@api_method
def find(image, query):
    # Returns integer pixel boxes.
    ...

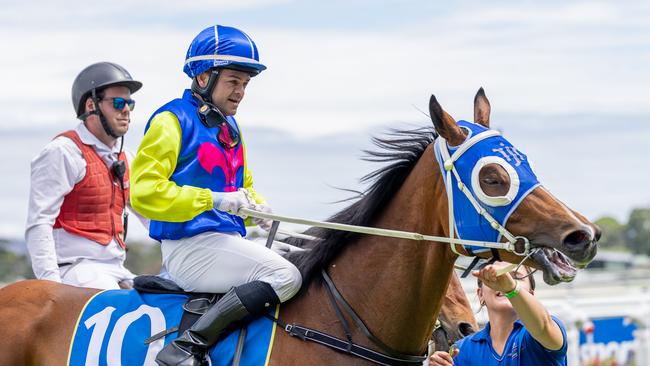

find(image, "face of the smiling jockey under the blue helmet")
[212,69,251,116]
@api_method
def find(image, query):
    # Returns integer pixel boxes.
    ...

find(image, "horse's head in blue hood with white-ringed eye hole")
[429,88,600,285]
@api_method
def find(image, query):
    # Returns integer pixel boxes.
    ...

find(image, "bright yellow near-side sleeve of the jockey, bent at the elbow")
[131,112,213,222]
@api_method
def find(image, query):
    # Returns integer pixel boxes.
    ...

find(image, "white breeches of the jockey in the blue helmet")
[161,232,302,302]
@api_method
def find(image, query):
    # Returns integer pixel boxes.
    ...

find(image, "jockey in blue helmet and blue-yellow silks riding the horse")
[131,25,302,365]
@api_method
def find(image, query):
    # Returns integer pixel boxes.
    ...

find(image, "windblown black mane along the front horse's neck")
[286,126,437,288]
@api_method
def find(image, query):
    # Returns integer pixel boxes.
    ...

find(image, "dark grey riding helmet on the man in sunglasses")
[72,62,142,117]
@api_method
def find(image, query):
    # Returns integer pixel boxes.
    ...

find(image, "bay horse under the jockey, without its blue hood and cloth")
[0,89,600,366]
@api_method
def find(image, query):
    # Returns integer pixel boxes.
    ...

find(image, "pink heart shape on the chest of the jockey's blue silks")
[197,142,244,192]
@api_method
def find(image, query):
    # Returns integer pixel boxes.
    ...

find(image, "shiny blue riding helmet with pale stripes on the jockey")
[183,25,266,78]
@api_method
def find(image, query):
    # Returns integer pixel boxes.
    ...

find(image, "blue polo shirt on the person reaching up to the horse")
[454,316,567,366]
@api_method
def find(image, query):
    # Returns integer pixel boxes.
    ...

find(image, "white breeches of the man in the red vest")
[60,258,135,290]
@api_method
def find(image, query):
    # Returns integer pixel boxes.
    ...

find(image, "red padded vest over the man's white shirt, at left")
[54,131,129,248]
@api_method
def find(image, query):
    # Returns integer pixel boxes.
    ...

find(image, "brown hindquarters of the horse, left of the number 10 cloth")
[0,280,97,366]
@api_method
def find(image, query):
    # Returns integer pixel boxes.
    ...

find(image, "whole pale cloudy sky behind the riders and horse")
[0,0,650,242]
